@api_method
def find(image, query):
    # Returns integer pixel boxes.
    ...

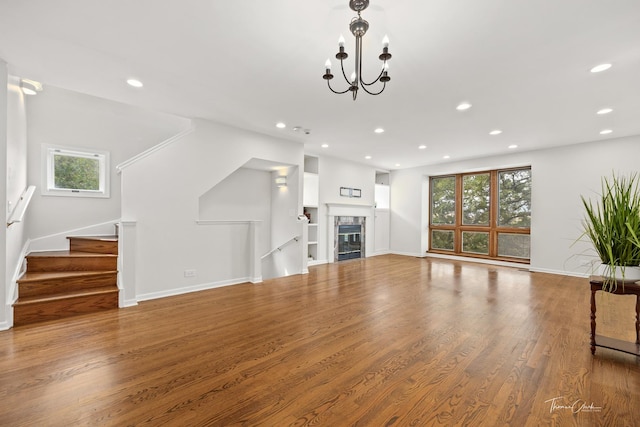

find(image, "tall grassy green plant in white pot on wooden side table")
[581,173,640,292]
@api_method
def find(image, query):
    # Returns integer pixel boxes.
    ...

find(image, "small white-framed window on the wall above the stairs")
[42,145,109,197]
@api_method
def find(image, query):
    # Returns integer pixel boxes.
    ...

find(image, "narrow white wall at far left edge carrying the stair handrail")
[0,69,27,329]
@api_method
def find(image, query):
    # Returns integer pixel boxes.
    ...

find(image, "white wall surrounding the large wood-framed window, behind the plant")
[391,136,640,275]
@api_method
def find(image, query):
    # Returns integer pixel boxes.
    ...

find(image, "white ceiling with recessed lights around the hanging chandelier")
[0,0,640,170]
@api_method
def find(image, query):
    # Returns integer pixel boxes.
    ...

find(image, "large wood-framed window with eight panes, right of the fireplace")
[429,167,531,262]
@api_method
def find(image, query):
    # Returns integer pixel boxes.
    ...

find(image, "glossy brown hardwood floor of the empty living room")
[0,255,640,426]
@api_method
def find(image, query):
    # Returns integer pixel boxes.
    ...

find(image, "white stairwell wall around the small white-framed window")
[27,85,190,239]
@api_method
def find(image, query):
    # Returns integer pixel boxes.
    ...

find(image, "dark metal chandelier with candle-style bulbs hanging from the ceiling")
[322,0,391,101]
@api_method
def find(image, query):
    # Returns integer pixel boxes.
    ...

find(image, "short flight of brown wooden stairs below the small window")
[13,236,118,326]
